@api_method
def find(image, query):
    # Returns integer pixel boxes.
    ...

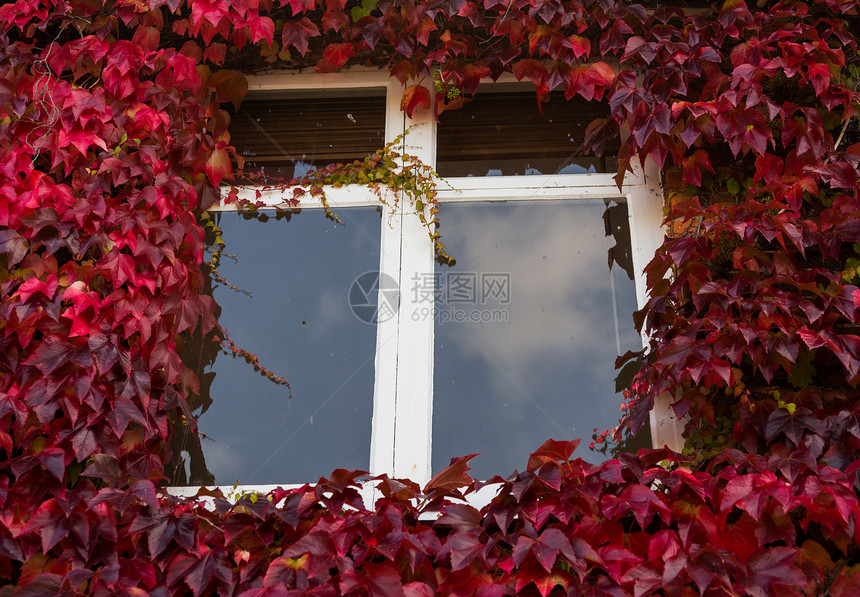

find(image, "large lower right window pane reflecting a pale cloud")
[433,200,641,478]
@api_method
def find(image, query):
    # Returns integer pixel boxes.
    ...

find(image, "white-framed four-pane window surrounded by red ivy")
[166,72,662,498]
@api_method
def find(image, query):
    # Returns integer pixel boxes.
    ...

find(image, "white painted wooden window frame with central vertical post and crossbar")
[170,69,682,498]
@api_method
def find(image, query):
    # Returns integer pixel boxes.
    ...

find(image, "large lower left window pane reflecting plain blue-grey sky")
[199,208,380,484]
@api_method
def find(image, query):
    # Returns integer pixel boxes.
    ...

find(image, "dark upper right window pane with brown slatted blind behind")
[436,92,618,176]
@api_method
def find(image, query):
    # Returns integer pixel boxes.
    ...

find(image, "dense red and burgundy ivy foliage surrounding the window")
[0,0,860,597]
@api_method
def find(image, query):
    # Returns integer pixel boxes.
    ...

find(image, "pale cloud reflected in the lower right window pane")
[444,203,632,379]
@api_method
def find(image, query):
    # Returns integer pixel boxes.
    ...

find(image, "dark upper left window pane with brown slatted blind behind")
[230,89,385,182]
